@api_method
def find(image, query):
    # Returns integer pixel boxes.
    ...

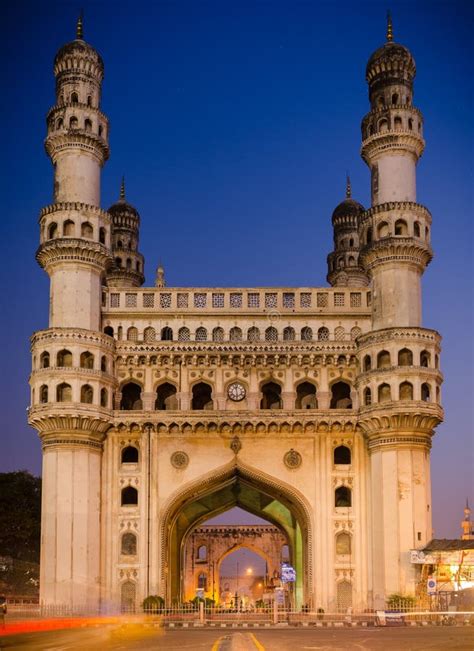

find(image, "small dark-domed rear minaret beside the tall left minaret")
[107,178,145,287]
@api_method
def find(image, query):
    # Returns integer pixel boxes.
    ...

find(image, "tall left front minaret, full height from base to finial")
[29,17,115,611]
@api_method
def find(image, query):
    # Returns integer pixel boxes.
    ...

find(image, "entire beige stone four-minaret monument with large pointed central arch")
[29,16,443,610]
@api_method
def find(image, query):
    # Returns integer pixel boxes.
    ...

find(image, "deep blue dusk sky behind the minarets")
[0,0,474,537]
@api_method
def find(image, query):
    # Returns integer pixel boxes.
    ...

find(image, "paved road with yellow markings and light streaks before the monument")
[0,626,474,651]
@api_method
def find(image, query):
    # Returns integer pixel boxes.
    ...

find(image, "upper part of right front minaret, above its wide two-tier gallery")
[359,16,432,329]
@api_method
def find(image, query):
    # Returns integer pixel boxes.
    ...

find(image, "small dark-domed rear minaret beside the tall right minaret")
[327,175,369,287]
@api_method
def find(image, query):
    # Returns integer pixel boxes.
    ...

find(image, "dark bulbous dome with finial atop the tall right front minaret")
[365,14,416,85]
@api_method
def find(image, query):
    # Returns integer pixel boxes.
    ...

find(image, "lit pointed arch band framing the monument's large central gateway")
[161,462,313,607]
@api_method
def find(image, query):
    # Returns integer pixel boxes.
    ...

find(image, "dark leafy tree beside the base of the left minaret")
[0,470,41,563]
